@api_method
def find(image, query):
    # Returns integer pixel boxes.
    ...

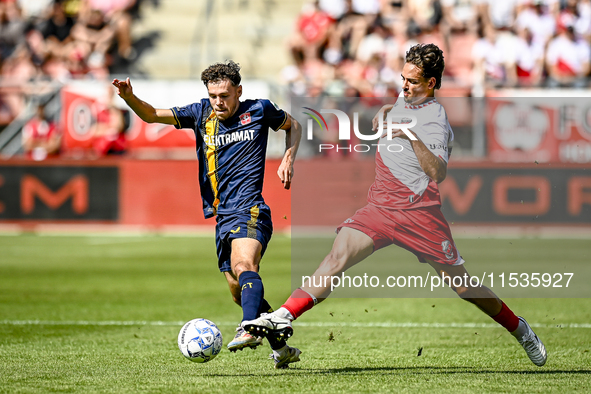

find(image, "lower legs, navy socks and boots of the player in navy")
[226,238,301,368]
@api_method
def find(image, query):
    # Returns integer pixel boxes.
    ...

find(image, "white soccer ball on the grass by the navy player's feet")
[178,319,222,363]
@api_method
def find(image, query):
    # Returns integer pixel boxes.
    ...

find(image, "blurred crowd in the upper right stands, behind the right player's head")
[282,0,591,97]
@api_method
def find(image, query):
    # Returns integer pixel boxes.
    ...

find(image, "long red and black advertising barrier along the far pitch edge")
[0,159,591,230]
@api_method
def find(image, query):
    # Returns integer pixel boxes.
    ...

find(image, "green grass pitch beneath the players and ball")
[0,235,591,393]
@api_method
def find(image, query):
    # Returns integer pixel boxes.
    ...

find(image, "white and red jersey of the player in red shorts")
[368,95,454,209]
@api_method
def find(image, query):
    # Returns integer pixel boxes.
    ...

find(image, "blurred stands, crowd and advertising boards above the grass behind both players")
[0,0,591,233]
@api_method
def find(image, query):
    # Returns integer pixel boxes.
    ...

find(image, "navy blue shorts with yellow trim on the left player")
[215,204,273,272]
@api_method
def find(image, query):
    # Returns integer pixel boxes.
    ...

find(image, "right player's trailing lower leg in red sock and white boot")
[427,260,548,367]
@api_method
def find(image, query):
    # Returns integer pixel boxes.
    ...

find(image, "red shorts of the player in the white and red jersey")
[337,204,464,265]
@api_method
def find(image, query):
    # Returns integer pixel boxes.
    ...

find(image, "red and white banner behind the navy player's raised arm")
[60,80,269,158]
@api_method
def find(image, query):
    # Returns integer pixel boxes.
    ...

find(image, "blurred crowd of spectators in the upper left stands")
[0,0,140,124]
